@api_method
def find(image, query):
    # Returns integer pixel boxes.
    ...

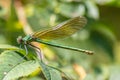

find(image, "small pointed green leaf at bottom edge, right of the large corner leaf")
[39,61,62,80]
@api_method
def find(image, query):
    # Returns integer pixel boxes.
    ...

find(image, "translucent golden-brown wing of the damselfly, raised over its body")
[32,17,87,40]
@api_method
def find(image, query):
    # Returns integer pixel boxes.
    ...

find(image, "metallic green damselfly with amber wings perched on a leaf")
[17,17,93,58]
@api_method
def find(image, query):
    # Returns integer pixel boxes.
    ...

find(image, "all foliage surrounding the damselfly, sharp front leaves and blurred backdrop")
[0,0,120,80]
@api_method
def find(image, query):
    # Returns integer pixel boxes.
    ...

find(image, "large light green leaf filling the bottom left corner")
[0,51,39,80]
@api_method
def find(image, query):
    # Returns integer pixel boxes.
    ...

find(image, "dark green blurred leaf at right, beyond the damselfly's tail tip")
[91,23,116,59]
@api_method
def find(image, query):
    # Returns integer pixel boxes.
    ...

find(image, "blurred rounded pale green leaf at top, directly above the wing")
[58,3,85,18]
